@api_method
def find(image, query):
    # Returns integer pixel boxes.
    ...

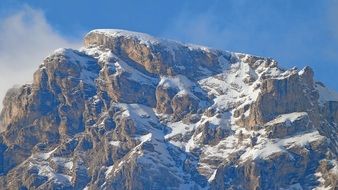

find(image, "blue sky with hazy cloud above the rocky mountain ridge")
[0,0,338,97]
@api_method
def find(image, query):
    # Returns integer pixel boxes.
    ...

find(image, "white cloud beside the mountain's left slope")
[0,6,80,109]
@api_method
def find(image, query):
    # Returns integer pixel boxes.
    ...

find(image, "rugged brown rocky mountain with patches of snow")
[0,30,338,190]
